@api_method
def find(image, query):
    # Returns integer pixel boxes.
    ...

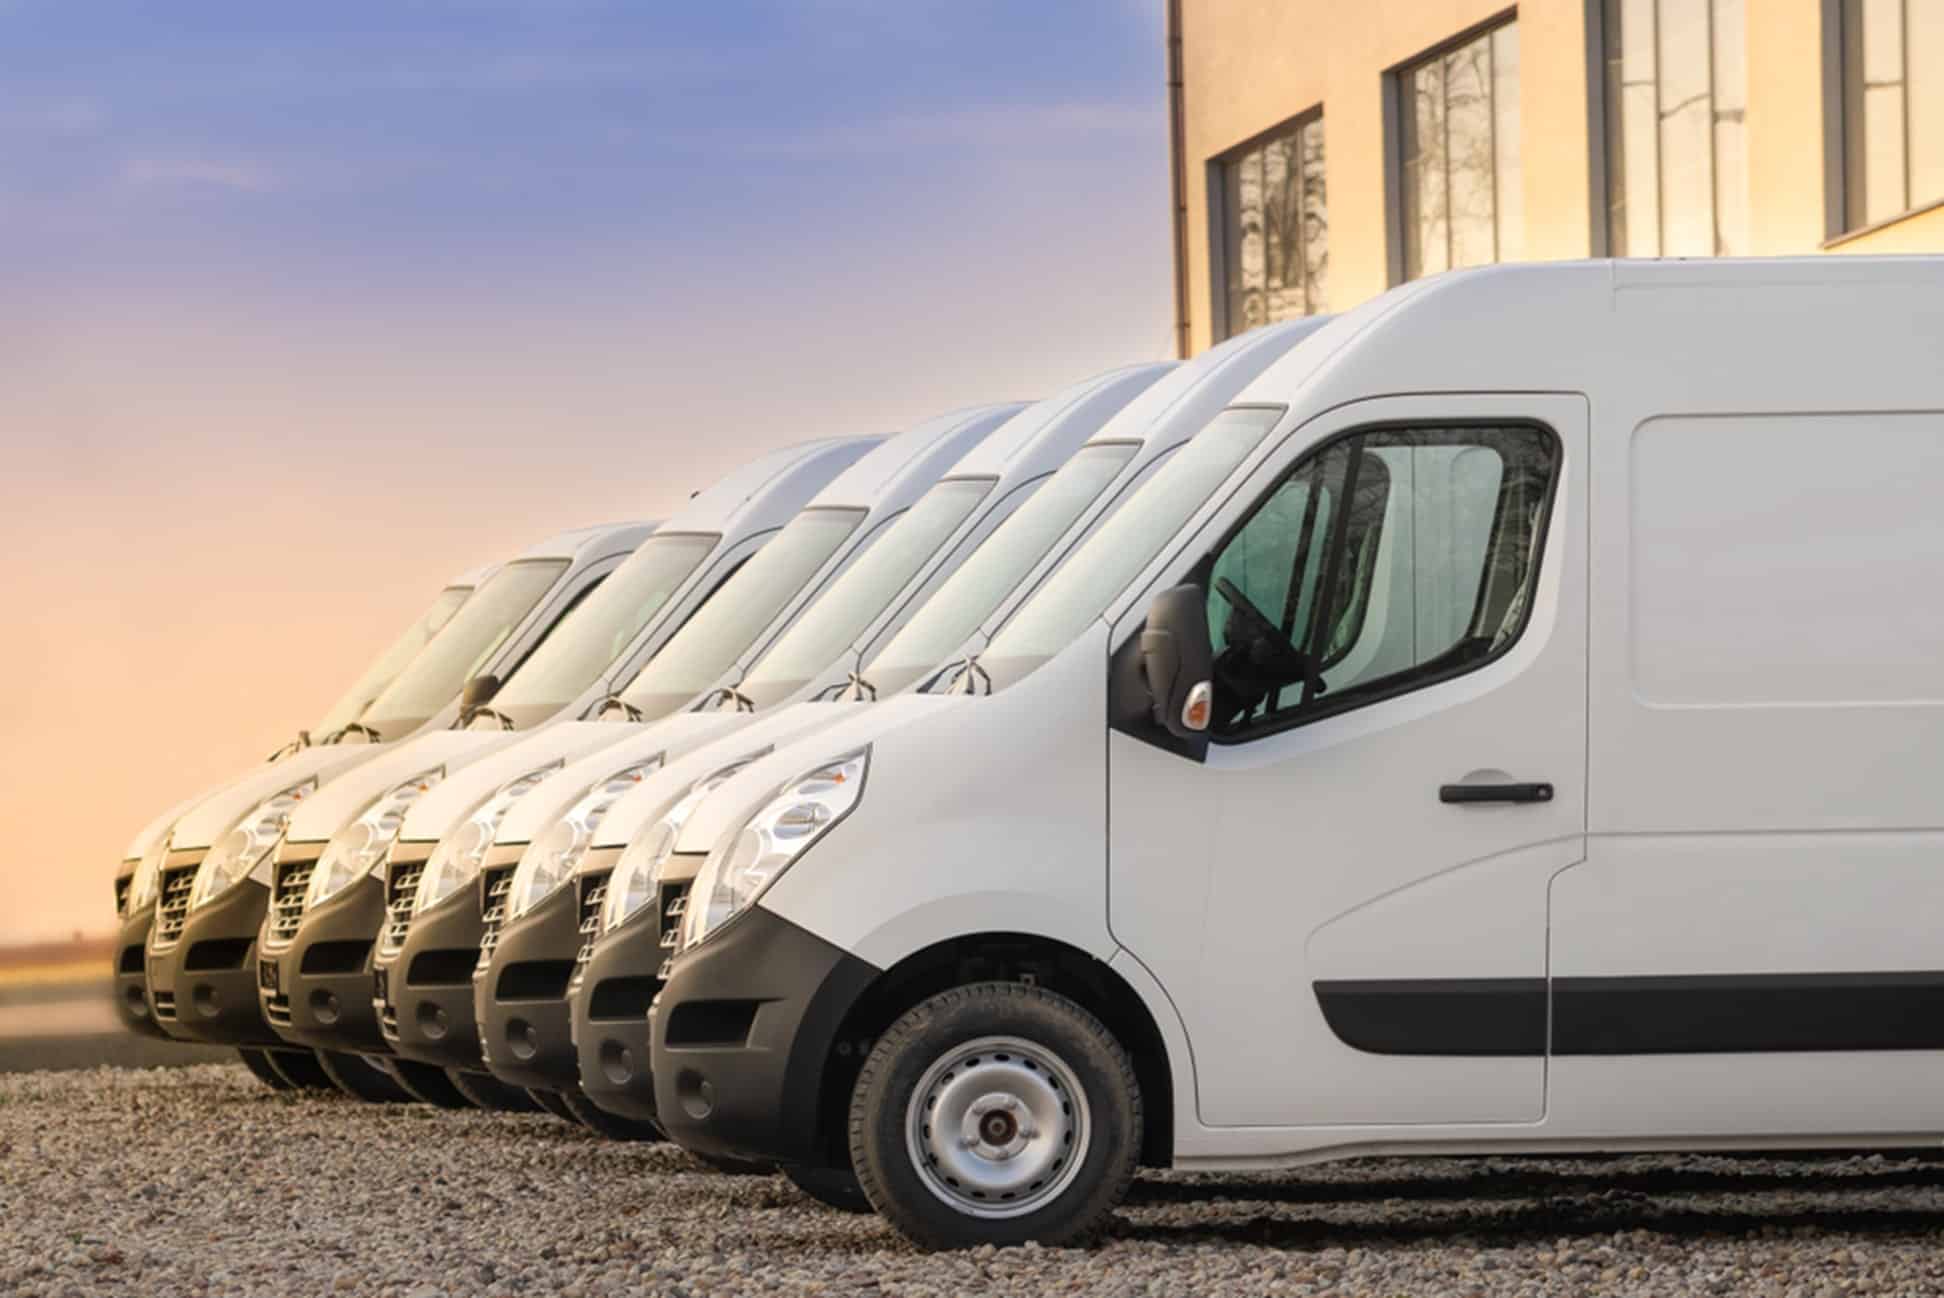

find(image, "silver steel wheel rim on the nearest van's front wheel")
[904,1036,1093,1218]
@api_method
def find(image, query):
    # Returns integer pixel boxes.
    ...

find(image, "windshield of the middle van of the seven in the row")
[622,509,865,721]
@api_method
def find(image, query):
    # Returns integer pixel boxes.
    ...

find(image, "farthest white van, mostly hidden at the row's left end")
[115,567,482,1080]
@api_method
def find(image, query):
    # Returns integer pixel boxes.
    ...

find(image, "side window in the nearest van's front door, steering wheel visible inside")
[1201,426,1559,736]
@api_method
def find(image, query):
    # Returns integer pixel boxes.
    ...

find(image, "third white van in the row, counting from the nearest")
[454,365,1172,1137]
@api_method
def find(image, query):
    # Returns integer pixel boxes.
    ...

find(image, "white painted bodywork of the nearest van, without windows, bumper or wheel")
[734,258,1944,1168]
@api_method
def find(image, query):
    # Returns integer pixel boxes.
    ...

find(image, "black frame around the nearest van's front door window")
[1186,416,1567,746]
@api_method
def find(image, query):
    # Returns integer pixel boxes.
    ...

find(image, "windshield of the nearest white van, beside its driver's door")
[972,406,1283,690]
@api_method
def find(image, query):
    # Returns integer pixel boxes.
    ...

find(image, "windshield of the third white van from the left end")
[494,534,717,713]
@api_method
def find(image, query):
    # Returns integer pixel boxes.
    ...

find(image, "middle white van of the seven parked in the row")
[365,406,1017,1113]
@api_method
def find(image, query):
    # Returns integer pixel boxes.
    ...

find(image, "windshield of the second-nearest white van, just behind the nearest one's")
[859,441,1139,694]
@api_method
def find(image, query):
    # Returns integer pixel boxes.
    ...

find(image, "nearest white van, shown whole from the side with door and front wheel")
[651,256,1944,1246]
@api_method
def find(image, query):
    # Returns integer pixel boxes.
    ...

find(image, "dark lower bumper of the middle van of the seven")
[365,888,484,1073]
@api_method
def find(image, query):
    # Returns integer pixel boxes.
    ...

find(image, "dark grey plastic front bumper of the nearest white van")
[649,905,879,1164]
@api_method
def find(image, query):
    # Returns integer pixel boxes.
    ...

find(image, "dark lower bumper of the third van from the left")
[257,876,385,1053]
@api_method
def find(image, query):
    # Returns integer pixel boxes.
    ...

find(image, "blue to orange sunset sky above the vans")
[0,0,1170,944]
